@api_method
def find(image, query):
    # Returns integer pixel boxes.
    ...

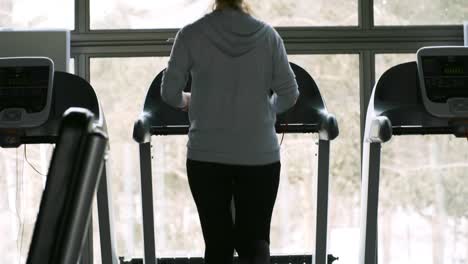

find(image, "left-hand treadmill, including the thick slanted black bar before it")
[0,57,117,264]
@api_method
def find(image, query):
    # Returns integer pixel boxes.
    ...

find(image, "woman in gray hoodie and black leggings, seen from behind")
[161,0,299,264]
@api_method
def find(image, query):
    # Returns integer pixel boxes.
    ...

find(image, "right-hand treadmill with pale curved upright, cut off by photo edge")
[359,47,468,264]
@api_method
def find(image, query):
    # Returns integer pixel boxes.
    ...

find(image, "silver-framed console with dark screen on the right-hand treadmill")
[417,47,468,118]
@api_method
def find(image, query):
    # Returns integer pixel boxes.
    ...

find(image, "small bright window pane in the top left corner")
[0,0,75,29]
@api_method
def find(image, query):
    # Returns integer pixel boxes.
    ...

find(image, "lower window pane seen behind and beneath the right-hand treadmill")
[376,54,468,264]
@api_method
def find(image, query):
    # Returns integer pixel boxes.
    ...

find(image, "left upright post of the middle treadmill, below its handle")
[140,143,156,264]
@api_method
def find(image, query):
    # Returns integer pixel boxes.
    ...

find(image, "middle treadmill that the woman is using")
[132,63,339,264]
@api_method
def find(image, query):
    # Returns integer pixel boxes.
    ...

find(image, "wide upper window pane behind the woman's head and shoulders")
[91,0,358,29]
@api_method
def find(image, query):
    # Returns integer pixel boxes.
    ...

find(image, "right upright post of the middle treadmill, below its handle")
[314,139,330,264]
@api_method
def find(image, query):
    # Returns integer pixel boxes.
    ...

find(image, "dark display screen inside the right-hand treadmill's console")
[422,56,468,103]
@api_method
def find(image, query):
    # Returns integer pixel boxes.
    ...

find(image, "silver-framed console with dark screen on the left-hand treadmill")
[0,57,54,128]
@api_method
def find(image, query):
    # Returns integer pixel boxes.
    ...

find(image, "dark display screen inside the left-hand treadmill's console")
[0,66,49,113]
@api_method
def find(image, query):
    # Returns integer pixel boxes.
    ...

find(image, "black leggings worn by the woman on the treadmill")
[187,159,281,264]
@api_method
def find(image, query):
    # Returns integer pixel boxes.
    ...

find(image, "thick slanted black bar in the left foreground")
[27,108,107,264]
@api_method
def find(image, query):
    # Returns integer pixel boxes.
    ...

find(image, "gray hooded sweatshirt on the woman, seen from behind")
[161,9,299,165]
